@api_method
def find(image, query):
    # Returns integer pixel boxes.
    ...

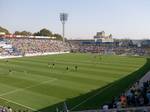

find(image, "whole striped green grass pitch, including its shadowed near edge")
[0,54,149,112]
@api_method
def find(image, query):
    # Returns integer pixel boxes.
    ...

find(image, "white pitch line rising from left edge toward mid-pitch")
[0,79,58,97]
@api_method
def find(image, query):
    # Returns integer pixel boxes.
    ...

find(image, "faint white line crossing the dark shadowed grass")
[70,84,113,110]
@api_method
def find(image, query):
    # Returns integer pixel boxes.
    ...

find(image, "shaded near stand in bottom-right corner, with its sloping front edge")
[101,72,150,112]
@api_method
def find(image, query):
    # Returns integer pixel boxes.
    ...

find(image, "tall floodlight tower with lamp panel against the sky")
[60,13,68,42]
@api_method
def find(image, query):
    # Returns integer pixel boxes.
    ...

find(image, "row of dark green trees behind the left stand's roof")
[0,26,62,40]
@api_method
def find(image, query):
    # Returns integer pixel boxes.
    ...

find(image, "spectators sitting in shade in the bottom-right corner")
[102,81,150,112]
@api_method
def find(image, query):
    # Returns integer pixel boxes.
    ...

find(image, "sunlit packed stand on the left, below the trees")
[0,38,70,55]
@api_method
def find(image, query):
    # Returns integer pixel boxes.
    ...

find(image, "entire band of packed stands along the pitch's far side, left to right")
[0,37,150,56]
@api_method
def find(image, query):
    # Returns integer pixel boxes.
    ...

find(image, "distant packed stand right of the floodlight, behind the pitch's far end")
[68,40,150,56]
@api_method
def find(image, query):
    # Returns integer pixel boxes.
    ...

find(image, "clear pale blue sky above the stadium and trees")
[0,0,150,39]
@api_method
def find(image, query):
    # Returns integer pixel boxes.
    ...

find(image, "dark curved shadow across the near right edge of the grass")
[34,59,150,112]
